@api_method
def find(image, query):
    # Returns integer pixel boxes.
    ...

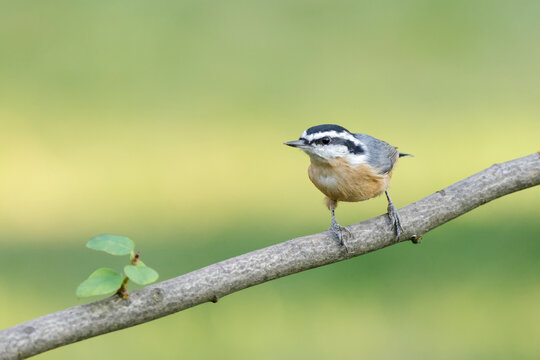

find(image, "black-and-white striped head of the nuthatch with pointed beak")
[285,124,366,164]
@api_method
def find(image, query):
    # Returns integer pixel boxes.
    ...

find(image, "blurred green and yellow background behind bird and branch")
[0,0,540,359]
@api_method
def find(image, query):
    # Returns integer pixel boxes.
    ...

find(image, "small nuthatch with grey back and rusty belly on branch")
[284,124,412,245]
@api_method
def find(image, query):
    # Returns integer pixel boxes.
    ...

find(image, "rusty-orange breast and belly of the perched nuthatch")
[308,158,392,201]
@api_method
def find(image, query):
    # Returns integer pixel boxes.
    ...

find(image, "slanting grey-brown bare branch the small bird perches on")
[0,153,540,360]
